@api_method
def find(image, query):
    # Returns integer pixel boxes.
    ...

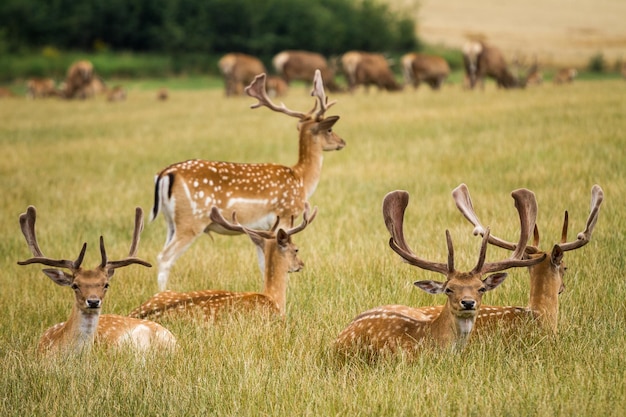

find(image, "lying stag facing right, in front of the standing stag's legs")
[129,203,317,320]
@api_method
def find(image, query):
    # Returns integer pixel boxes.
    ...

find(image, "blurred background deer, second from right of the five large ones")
[400,52,450,90]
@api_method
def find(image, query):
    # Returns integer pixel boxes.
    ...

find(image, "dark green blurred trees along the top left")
[0,0,417,57]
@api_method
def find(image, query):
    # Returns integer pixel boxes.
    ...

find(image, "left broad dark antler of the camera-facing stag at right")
[383,190,449,275]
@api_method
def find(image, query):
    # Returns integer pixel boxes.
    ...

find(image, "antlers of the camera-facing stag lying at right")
[383,191,545,275]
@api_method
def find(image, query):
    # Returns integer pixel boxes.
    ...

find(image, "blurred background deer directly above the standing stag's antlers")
[272,51,341,92]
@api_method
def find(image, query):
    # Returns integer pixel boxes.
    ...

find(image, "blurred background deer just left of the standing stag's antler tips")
[217,53,266,97]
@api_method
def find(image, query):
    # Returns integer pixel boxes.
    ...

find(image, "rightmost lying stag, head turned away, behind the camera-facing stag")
[452,184,604,333]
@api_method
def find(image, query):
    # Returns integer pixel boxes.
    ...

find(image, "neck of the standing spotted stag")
[292,128,324,198]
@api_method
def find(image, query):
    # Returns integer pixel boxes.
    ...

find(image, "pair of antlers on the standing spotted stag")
[244,70,336,121]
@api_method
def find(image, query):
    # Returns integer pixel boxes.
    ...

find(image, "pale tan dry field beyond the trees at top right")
[386,0,626,67]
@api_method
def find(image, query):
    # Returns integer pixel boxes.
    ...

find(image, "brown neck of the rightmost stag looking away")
[529,261,561,330]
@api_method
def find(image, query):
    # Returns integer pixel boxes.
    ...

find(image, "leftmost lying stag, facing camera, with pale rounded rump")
[18,206,176,353]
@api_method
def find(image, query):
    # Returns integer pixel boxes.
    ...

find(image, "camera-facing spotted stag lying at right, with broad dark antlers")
[335,191,543,354]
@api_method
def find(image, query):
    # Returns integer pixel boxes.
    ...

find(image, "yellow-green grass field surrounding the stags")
[0,80,626,417]
